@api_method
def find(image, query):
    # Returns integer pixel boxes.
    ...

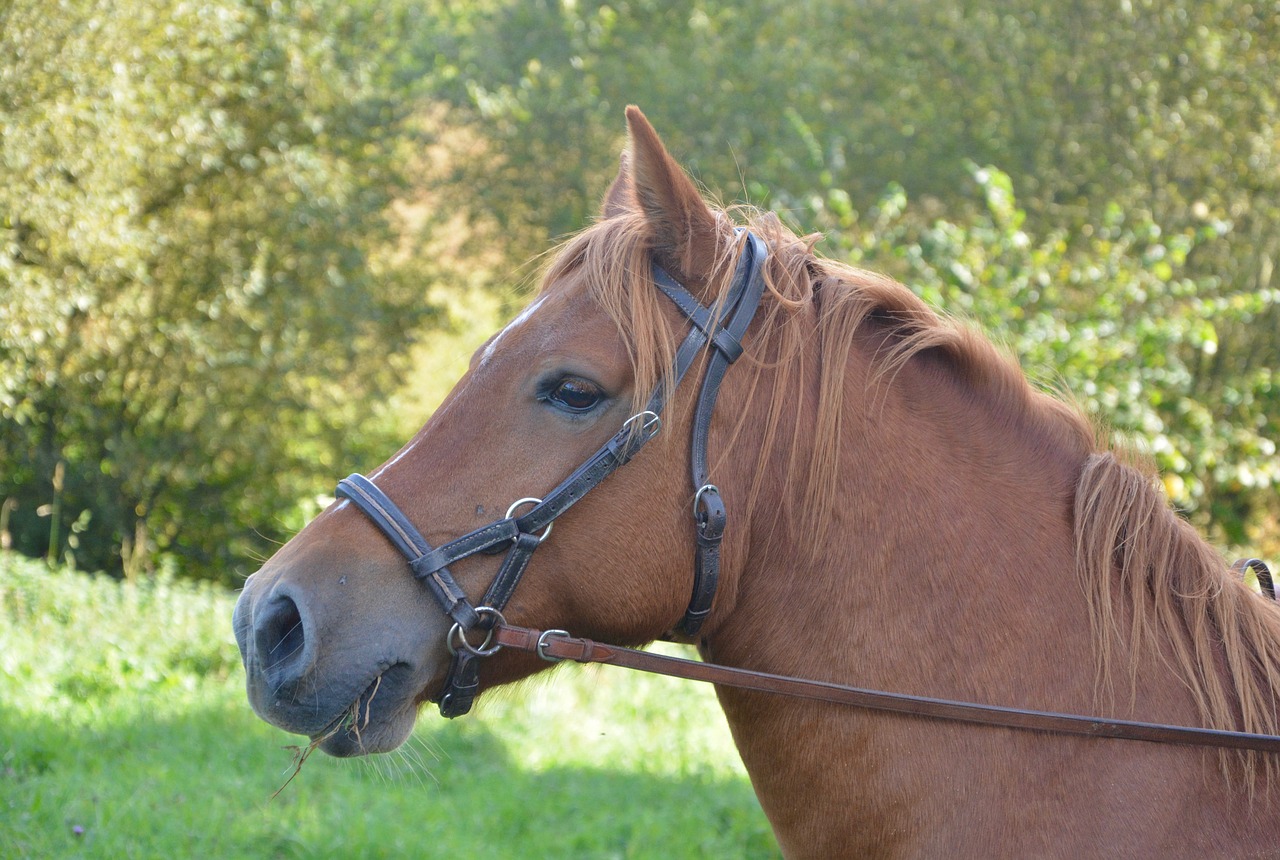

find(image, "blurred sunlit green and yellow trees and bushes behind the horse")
[0,0,1280,582]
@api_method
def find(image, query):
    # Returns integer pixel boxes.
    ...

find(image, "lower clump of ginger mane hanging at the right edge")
[1074,452,1280,784]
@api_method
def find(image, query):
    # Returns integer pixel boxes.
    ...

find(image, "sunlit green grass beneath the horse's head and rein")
[0,553,777,860]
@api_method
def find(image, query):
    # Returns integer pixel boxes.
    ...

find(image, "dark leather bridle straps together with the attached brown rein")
[337,233,1280,737]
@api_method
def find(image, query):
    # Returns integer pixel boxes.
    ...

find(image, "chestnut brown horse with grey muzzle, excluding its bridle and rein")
[234,108,1280,857]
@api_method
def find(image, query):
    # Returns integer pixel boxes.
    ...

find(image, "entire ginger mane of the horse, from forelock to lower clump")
[543,202,1280,784]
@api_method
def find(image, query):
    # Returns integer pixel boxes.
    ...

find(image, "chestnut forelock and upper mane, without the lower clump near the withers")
[543,207,1097,537]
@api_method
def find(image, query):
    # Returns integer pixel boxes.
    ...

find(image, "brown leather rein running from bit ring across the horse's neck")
[485,622,1280,754]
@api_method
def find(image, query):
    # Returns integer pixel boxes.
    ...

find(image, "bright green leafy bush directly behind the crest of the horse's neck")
[814,165,1280,544]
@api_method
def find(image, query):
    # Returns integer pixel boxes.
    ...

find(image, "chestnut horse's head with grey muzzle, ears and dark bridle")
[234,108,764,755]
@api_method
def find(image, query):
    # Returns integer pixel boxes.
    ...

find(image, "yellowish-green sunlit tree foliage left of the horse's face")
[0,0,428,577]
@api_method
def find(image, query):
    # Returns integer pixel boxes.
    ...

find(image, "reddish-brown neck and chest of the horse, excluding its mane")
[703,291,1280,856]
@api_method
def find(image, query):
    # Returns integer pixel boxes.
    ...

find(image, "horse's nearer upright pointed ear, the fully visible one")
[627,105,718,285]
